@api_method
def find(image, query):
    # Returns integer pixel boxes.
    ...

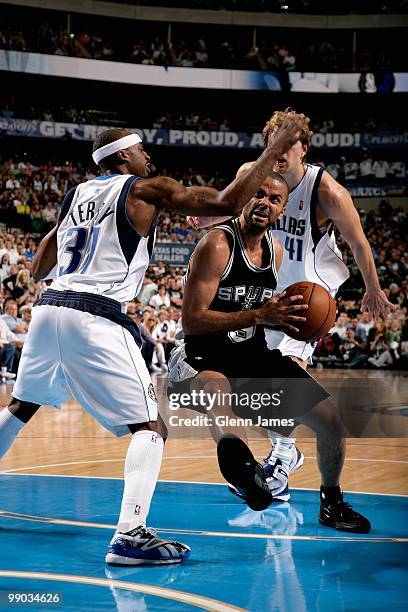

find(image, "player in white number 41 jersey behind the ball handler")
[190,109,393,501]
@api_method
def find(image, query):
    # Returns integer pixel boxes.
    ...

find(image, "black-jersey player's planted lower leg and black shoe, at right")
[297,399,371,533]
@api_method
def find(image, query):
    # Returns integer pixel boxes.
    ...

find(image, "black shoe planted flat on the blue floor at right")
[319,493,371,533]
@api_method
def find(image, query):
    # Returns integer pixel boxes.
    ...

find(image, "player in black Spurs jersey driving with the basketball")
[170,173,371,533]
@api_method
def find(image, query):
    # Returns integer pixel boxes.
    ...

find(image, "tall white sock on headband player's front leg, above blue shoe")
[117,429,164,533]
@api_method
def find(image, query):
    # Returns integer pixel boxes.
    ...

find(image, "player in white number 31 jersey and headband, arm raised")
[0,116,303,565]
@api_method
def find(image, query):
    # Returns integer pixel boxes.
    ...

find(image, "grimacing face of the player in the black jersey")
[243,179,288,231]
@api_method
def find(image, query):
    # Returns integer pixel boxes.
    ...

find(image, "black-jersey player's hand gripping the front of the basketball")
[258,291,308,333]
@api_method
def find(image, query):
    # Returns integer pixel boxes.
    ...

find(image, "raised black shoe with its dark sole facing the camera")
[217,434,273,510]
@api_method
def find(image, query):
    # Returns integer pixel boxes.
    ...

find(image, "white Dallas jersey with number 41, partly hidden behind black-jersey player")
[272,164,349,293]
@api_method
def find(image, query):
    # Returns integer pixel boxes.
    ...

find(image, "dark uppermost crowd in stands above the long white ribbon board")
[0,12,404,72]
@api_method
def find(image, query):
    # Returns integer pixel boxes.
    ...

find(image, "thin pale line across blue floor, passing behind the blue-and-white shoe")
[0,510,408,543]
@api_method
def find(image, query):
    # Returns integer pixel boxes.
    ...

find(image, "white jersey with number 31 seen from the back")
[51,174,155,312]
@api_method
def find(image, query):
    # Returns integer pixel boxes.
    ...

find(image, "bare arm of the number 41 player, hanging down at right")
[318,172,394,315]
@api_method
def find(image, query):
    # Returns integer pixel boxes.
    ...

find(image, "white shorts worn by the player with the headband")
[13,305,158,436]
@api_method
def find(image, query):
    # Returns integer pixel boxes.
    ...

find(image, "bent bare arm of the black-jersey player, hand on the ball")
[182,230,307,335]
